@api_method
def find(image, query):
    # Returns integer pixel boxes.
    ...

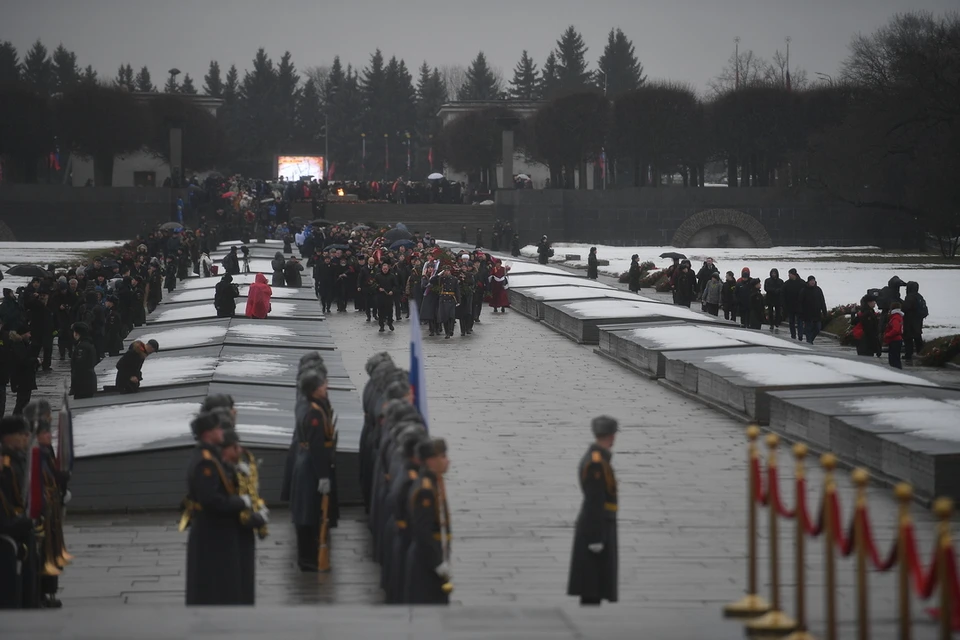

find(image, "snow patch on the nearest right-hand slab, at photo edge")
[842,397,960,442]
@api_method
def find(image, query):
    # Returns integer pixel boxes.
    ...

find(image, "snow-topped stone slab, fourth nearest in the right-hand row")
[542,298,717,344]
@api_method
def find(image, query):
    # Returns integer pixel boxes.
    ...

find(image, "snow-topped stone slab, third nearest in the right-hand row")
[599,322,809,378]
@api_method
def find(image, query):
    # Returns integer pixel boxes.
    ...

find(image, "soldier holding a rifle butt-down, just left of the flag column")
[290,369,335,571]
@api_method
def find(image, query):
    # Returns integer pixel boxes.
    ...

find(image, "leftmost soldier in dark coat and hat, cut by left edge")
[0,415,40,609]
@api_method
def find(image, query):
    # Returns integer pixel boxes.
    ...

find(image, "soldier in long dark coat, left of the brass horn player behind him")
[184,412,252,605]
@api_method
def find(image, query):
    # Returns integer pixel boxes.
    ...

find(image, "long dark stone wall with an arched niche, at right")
[496,187,916,249]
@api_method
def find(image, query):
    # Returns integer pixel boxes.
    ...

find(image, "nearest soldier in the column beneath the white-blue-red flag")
[403,439,450,604]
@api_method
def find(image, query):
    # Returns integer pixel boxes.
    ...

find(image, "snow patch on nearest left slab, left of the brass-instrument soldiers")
[73,400,200,458]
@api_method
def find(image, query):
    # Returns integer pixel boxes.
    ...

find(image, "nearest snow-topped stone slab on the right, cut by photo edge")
[767,384,960,499]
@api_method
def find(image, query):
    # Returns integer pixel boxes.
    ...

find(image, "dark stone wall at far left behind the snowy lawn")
[0,185,187,241]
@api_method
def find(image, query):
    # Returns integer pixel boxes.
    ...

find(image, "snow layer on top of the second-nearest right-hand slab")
[705,353,938,387]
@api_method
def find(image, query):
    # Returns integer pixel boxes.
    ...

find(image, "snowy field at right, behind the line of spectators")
[524,242,960,337]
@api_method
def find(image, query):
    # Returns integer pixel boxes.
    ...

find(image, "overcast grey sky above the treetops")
[0,0,960,89]
